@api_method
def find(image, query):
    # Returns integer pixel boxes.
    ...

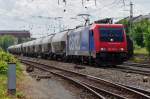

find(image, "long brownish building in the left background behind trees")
[0,30,31,43]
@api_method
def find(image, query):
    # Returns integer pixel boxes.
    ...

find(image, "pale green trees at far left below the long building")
[0,35,17,51]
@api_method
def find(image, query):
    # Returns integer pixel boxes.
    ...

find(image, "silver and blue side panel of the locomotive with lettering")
[67,27,89,56]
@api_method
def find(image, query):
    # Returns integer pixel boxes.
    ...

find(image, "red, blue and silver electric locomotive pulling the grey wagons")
[66,24,127,65]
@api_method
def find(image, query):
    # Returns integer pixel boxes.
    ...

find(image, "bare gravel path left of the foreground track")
[18,66,94,99]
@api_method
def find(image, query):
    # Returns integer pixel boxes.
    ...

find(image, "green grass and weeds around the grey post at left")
[0,50,23,99]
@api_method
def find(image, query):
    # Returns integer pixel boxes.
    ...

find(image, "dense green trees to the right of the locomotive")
[119,19,150,55]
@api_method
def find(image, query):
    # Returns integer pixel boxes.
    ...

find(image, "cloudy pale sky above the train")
[0,0,150,38]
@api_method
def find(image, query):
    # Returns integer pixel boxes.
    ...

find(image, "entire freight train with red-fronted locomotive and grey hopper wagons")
[8,23,133,65]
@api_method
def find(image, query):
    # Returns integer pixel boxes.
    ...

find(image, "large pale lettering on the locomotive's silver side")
[69,32,80,50]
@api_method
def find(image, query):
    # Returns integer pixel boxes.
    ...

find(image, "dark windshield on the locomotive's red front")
[100,28,123,42]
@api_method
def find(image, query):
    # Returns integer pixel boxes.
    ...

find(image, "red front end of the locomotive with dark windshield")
[92,24,127,64]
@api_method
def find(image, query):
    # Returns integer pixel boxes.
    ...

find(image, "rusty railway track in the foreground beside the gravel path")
[21,59,150,99]
